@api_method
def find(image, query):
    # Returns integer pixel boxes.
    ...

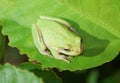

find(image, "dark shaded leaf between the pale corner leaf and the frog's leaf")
[18,62,62,83]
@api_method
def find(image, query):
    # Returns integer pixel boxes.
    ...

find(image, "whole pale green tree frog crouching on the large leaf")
[32,16,82,62]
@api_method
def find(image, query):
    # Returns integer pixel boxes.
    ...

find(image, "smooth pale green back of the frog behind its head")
[39,20,75,40]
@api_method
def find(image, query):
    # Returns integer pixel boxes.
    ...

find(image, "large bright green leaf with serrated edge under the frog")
[0,0,120,70]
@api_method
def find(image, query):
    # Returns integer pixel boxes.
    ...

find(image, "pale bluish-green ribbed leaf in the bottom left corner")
[0,64,43,83]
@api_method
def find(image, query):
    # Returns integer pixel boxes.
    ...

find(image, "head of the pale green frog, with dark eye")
[58,37,83,57]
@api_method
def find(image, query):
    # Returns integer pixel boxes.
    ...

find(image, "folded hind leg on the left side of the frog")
[32,24,51,56]
